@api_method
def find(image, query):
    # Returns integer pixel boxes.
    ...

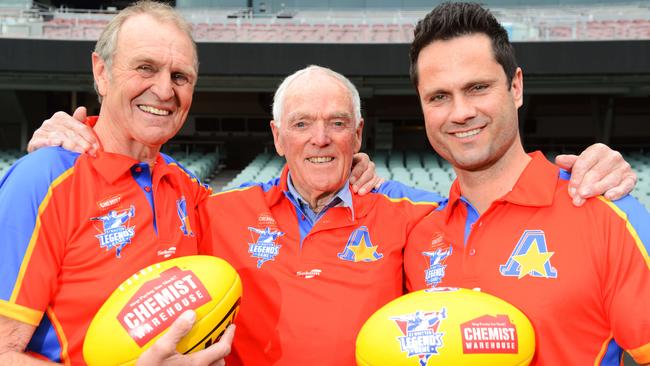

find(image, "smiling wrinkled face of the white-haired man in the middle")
[271,71,363,202]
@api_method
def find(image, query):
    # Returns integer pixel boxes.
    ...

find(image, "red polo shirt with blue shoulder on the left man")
[0,144,210,365]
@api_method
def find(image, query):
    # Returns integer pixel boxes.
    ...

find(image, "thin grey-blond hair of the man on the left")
[94,0,199,103]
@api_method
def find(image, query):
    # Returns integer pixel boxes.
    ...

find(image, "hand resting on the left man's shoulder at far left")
[27,107,99,156]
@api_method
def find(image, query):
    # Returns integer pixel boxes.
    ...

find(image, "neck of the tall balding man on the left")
[94,115,160,166]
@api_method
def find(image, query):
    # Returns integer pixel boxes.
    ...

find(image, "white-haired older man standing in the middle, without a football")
[199,66,441,365]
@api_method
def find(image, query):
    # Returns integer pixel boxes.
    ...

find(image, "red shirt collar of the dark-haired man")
[446,151,560,220]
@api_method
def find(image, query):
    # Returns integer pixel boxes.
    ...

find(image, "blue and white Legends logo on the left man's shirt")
[90,205,135,258]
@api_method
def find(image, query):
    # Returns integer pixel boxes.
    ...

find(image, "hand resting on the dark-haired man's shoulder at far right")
[555,144,637,206]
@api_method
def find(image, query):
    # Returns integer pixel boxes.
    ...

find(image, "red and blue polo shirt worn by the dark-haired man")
[405,153,650,366]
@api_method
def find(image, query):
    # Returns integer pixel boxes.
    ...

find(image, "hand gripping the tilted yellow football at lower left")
[137,310,235,366]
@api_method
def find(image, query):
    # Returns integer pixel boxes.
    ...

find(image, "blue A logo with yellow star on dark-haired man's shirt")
[499,230,557,279]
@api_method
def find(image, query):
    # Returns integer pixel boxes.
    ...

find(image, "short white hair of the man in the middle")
[273,65,361,127]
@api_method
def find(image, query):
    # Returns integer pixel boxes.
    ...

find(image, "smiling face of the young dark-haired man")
[417,34,523,171]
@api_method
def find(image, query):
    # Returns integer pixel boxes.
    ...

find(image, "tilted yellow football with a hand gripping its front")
[83,255,242,366]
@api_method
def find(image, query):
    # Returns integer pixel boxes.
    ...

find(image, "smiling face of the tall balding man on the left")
[93,14,197,154]
